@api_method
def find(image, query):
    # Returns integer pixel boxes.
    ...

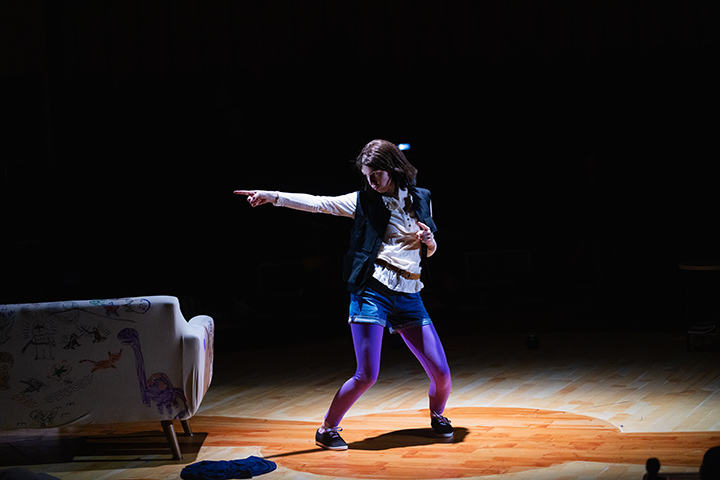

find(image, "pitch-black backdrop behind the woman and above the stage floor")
[0,0,720,342]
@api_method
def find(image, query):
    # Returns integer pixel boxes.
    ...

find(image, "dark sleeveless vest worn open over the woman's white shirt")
[343,187,437,293]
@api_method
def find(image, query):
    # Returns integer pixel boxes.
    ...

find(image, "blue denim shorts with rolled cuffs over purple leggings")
[348,280,432,333]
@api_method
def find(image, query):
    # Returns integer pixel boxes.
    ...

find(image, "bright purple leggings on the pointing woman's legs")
[325,323,452,427]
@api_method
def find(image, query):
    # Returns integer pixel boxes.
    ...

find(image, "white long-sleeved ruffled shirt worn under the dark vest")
[273,189,436,293]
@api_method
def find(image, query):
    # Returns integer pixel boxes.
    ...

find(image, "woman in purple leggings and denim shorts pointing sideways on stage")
[235,140,453,450]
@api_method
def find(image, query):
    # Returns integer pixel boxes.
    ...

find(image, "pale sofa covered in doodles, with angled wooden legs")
[0,296,214,459]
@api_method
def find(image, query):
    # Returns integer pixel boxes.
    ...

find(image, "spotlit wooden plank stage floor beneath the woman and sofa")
[0,331,720,480]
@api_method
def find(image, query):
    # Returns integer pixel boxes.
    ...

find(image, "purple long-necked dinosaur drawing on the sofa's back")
[118,328,187,418]
